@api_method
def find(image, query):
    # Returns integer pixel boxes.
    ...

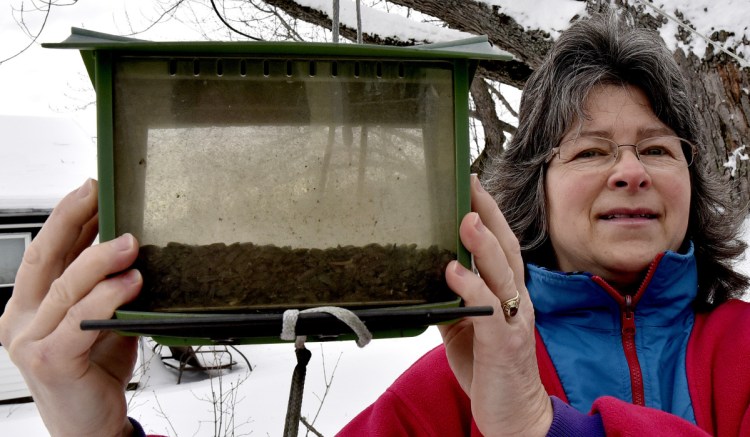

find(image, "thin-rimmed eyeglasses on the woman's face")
[547,135,697,170]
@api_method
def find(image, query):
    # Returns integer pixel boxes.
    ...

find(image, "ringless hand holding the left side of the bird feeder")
[0,180,141,436]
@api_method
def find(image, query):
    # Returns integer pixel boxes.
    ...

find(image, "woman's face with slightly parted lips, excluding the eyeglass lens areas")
[545,85,690,286]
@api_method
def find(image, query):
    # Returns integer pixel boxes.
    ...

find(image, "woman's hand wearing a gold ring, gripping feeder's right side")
[440,176,553,436]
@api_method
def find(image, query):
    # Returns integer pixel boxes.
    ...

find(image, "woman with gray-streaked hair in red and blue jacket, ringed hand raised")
[341,11,750,436]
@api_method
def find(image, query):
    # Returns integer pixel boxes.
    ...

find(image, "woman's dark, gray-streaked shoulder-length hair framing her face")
[482,12,748,310]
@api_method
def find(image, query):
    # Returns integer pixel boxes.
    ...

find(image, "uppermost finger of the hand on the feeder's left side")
[13,179,98,311]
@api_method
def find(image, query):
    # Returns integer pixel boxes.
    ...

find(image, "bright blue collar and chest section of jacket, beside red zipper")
[526,244,698,423]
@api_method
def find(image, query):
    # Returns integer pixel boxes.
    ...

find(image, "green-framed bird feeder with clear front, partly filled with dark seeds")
[45,29,508,343]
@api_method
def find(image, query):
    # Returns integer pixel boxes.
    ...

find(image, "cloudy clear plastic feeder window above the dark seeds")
[113,58,457,306]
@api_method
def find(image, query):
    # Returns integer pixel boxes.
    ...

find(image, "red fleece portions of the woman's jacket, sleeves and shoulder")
[338,301,750,437]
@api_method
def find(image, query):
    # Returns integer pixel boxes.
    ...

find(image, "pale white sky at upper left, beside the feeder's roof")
[0,0,212,136]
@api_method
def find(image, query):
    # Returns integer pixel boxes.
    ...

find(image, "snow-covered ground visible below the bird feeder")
[0,327,440,437]
